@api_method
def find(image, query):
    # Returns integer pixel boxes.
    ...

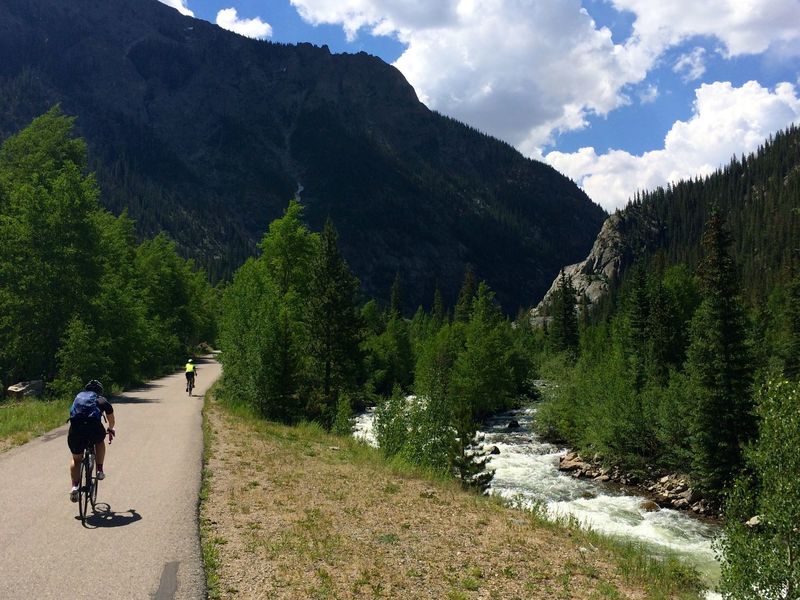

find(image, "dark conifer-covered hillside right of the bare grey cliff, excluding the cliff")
[623,125,800,299]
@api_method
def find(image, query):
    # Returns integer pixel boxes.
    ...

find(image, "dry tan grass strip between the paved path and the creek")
[201,400,699,600]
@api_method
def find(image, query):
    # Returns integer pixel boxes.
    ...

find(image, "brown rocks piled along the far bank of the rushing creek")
[558,452,719,518]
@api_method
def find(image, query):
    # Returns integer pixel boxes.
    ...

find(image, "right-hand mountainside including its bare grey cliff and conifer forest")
[533,125,800,317]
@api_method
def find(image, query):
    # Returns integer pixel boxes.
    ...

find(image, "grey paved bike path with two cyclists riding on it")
[0,359,221,600]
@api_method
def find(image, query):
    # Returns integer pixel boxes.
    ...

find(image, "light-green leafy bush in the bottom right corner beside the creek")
[717,380,800,600]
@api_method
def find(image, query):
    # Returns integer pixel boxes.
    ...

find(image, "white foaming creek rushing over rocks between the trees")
[354,405,719,598]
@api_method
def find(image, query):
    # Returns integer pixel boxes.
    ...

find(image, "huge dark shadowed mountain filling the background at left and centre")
[0,0,604,310]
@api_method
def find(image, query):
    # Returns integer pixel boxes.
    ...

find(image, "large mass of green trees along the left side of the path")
[0,108,215,391]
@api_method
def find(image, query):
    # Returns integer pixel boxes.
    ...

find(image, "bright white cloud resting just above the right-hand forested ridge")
[545,81,800,211]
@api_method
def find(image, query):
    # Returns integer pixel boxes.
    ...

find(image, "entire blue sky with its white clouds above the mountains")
[161,0,800,210]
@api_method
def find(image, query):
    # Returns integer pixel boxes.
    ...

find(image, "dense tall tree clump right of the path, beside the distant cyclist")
[220,200,362,428]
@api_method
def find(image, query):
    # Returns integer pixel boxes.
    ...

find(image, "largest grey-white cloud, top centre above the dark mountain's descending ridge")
[292,0,653,154]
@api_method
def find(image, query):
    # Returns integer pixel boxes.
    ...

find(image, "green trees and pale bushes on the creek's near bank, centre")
[378,282,531,488]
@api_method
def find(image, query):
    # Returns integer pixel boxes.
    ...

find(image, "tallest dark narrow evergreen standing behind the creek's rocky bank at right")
[686,213,755,498]
